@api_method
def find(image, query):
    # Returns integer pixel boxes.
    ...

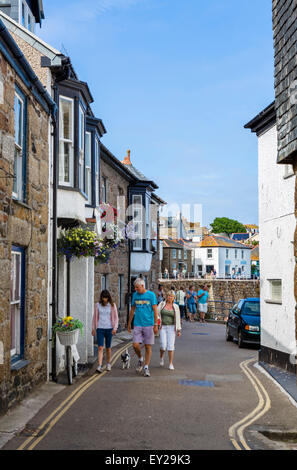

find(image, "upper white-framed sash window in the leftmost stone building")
[13,92,26,201]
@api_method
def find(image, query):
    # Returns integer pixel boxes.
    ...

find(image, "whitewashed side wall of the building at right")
[258,126,296,353]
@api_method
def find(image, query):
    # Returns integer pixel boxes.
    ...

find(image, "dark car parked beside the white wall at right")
[226,298,261,348]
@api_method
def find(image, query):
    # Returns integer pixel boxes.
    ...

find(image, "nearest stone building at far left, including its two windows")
[0,20,56,413]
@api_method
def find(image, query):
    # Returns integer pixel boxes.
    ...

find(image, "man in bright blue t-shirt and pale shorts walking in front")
[128,278,158,377]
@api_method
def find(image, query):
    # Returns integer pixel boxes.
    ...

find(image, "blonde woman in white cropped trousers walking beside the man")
[158,290,181,370]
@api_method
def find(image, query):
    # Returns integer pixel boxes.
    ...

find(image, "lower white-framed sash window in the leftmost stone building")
[10,247,24,359]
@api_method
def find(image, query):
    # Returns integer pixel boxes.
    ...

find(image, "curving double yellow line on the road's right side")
[229,358,271,450]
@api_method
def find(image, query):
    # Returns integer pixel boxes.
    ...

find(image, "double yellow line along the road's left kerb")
[17,343,132,450]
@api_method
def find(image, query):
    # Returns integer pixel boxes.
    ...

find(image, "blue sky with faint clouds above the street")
[37,0,274,225]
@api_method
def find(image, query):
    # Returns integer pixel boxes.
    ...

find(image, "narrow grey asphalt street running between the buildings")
[4,322,297,451]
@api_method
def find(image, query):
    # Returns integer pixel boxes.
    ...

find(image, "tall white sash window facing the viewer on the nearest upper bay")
[59,96,74,186]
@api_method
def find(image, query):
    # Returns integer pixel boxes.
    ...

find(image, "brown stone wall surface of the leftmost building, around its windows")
[0,50,49,413]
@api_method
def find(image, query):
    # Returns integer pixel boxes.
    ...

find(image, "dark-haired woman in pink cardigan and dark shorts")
[92,290,119,374]
